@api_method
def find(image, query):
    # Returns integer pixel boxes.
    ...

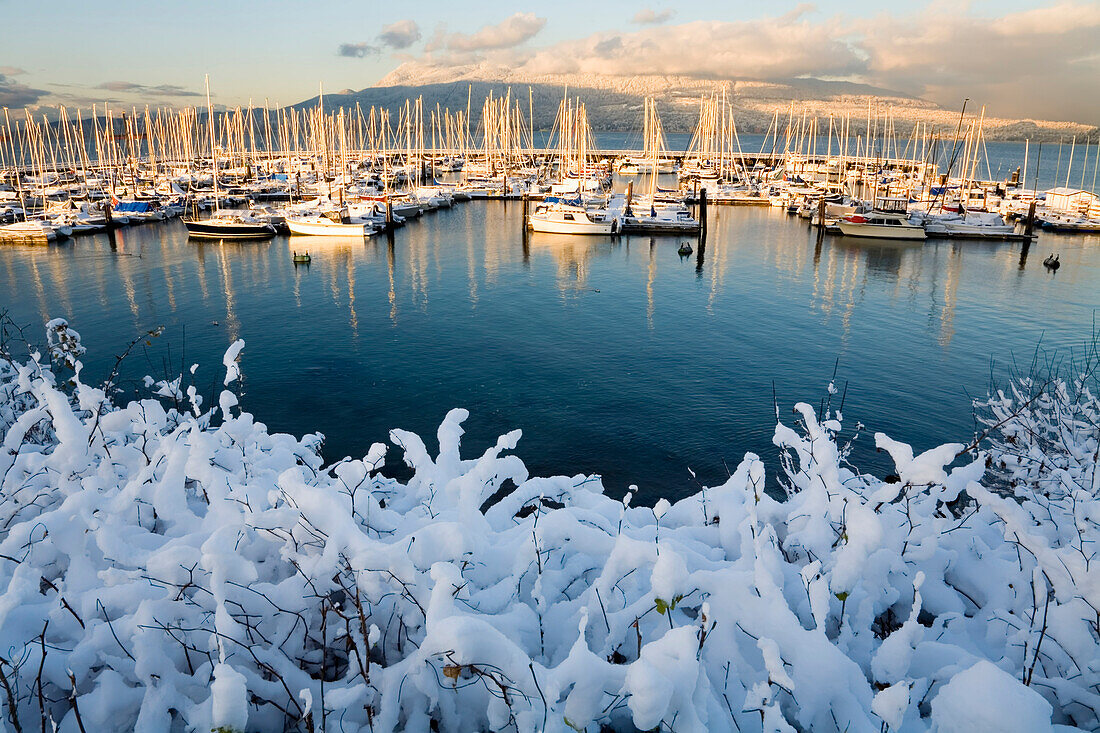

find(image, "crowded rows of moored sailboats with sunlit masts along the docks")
[0,91,1100,243]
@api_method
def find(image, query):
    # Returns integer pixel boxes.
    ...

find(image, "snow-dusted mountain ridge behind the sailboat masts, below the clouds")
[295,62,1096,140]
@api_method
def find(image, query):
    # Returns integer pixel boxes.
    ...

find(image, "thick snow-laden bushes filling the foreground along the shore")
[0,321,1100,733]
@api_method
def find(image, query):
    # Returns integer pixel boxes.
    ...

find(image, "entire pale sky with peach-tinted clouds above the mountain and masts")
[0,0,1100,124]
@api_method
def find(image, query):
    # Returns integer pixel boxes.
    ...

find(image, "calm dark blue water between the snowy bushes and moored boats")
[0,208,1100,499]
